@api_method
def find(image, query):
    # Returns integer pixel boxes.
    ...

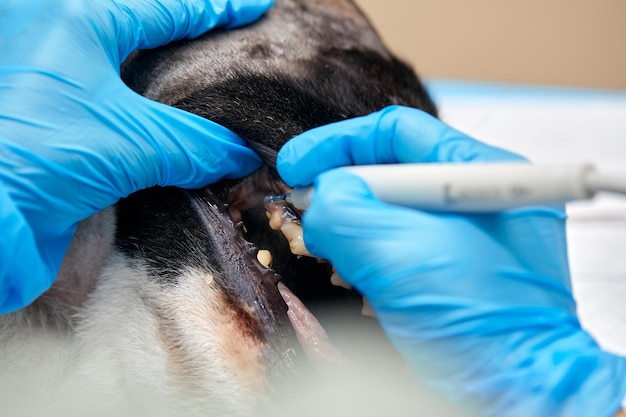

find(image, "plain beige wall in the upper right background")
[356,0,626,90]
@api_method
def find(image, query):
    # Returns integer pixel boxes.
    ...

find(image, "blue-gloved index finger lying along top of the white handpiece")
[277,106,521,186]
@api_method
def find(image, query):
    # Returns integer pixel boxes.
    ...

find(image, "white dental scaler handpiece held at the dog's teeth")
[276,162,626,212]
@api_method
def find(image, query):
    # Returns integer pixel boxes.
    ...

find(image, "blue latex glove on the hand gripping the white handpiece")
[278,107,626,417]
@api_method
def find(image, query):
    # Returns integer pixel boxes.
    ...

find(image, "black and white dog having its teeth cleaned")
[0,0,464,416]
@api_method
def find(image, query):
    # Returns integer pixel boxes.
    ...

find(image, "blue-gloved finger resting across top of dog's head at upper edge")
[109,0,273,62]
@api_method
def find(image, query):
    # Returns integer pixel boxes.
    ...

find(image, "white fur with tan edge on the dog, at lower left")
[0,249,265,417]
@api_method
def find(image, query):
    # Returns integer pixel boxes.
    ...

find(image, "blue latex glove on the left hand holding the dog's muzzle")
[0,0,272,312]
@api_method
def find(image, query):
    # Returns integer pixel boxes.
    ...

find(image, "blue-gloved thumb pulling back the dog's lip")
[100,93,262,197]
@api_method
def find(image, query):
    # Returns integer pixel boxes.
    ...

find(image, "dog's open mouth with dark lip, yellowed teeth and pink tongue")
[200,162,360,380]
